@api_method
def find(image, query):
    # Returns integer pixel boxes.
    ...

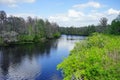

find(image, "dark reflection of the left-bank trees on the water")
[0,40,57,77]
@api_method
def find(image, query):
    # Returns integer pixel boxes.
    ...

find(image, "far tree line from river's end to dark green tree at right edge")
[60,14,120,36]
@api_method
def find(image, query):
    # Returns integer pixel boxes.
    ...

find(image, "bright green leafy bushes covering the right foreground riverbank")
[57,33,120,80]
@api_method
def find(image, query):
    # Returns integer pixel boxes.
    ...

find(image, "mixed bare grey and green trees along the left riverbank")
[0,11,60,44]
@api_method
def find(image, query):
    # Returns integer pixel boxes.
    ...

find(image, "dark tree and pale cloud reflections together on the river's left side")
[0,40,57,80]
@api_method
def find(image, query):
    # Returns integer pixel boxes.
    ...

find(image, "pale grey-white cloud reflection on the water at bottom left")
[8,58,40,80]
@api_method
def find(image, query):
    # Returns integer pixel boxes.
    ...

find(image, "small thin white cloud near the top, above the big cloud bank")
[73,1,102,8]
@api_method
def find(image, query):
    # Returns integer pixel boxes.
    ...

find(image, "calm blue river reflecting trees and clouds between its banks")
[0,35,84,80]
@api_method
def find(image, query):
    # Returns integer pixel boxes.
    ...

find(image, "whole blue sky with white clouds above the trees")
[0,0,120,27]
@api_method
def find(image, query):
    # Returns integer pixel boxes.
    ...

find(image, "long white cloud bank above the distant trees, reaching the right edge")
[48,9,120,27]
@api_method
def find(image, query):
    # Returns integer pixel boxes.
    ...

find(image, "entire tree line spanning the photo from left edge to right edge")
[0,11,120,45]
